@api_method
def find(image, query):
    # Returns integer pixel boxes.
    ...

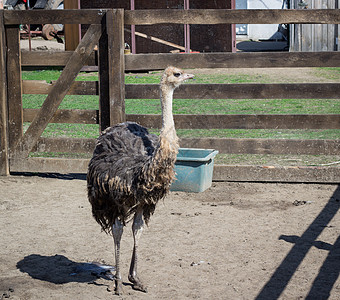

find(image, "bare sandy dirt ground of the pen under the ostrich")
[0,174,340,299]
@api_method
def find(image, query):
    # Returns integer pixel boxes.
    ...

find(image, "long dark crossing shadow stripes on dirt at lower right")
[256,186,340,300]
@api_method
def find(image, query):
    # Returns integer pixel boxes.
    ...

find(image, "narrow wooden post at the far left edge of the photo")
[0,10,9,176]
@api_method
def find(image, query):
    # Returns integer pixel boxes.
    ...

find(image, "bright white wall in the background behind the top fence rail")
[236,0,283,40]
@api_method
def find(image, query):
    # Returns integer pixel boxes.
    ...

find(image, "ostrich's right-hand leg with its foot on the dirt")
[129,209,147,293]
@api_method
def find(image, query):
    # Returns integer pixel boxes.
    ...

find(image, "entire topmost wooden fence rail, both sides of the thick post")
[4,9,340,25]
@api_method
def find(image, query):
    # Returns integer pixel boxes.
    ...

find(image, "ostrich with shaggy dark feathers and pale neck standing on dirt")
[87,67,194,295]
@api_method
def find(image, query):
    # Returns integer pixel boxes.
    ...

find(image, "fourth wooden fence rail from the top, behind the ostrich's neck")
[24,108,340,129]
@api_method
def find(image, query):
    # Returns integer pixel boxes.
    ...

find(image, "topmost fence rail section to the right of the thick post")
[124,9,340,25]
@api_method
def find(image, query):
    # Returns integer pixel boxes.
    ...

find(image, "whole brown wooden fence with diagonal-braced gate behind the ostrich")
[0,9,340,183]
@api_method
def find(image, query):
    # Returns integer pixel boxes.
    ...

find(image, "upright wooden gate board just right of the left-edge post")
[5,25,23,151]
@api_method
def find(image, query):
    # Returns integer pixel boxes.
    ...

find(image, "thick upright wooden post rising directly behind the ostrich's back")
[99,9,126,130]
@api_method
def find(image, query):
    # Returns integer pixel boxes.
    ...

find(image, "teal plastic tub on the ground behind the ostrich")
[170,148,218,193]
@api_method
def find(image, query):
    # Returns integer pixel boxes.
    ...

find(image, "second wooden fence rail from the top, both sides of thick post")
[21,51,340,71]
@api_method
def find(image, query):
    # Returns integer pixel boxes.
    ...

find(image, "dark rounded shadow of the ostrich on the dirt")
[17,254,114,284]
